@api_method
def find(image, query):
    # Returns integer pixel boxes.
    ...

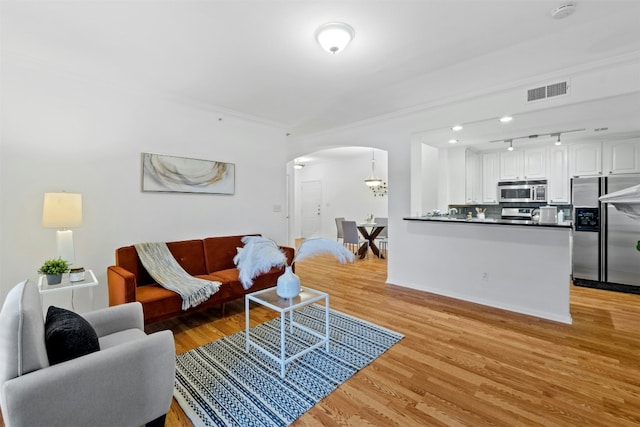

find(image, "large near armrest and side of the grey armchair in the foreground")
[0,331,175,427]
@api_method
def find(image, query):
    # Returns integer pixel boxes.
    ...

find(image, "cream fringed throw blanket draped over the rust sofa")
[134,243,221,310]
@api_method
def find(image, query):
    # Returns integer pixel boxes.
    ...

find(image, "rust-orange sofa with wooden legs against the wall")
[107,236,294,325]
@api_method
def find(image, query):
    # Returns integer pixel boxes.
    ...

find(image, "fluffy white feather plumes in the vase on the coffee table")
[233,236,355,289]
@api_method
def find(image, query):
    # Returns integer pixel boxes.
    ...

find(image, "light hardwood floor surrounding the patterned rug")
[149,255,640,427]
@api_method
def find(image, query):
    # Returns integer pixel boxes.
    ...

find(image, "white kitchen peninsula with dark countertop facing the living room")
[401,217,571,323]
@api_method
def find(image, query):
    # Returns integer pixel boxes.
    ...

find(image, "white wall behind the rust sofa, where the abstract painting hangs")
[0,57,287,310]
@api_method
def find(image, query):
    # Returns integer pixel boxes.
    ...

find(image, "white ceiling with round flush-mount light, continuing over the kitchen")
[0,0,640,152]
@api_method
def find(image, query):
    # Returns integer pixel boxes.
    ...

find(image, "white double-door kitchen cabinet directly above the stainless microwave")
[500,147,547,180]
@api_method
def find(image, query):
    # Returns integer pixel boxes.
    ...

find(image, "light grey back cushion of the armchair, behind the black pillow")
[0,280,49,384]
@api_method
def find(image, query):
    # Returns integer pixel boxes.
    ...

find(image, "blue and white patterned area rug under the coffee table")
[173,305,403,427]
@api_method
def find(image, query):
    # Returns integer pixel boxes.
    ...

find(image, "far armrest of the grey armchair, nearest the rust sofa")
[82,302,144,337]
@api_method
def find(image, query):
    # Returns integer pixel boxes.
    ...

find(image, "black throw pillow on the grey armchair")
[44,306,100,365]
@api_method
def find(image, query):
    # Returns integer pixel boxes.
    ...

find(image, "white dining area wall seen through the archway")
[294,150,389,239]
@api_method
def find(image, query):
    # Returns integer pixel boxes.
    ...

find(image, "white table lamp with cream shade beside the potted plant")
[42,193,82,264]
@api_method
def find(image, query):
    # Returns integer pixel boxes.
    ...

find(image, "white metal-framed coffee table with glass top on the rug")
[244,287,329,378]
